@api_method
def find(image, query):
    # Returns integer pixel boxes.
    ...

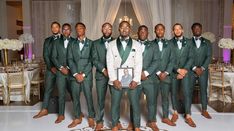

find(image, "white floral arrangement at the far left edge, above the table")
[0,39,23,51]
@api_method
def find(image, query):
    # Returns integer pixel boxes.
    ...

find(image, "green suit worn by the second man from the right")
[171,37,194,114]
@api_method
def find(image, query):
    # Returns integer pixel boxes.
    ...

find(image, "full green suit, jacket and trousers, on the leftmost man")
[42,36,59,109]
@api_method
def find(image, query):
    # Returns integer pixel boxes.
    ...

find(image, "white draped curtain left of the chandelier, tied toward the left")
[81,0,121,39]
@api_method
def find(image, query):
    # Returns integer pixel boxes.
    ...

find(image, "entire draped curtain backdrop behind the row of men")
[32,0,223,56]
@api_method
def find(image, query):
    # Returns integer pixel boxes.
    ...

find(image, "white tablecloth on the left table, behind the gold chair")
[0,68,39,104]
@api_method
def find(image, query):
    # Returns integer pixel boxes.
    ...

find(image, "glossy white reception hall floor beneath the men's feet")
[0,90,234,131]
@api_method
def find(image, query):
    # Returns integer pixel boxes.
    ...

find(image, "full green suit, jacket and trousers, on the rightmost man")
[192,37,212,110]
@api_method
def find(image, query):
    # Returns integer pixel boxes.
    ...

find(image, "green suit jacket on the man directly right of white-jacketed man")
[142,41,159,82]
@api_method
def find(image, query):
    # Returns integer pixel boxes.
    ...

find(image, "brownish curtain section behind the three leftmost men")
[32,0,80,57]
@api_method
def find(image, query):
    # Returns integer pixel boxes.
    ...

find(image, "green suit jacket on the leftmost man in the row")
[43,36,59,70]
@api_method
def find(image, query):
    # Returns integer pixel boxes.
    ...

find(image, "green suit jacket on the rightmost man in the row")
[191,37,212,70]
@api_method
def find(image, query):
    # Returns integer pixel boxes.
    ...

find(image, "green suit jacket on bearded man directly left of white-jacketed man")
[92,38,113,79]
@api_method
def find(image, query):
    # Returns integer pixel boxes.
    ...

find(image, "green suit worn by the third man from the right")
[152,39,175,118]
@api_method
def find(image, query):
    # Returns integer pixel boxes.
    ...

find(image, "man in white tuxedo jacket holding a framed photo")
[106,21,142,131]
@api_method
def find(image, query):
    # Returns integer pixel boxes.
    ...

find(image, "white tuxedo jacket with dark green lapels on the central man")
[106,39,143,85]
